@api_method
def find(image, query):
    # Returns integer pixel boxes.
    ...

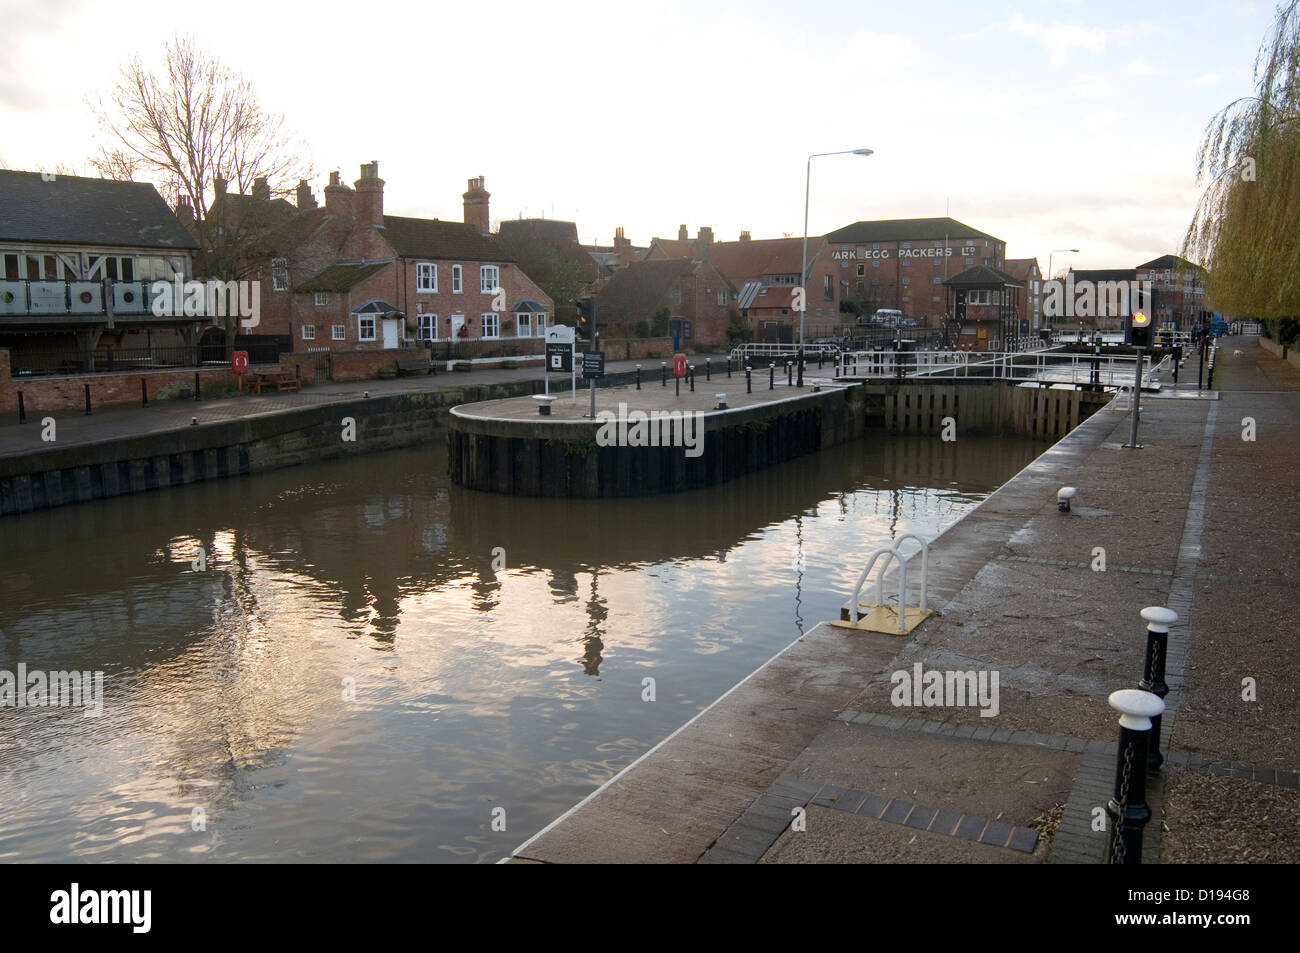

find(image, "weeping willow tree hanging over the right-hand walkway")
[1183,0,1300,337]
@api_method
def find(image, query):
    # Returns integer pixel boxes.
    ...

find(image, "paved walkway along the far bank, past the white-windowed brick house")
[0,355,727,456]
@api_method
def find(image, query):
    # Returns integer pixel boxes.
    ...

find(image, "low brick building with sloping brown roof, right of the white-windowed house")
[595,257,736,347]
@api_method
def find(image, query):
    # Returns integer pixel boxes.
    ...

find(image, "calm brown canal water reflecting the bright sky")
[0,436,1044,862]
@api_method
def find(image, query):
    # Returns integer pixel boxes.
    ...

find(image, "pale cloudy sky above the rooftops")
[0,0,1275,269]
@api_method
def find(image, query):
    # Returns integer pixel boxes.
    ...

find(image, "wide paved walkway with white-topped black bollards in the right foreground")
[506,338,1300,863]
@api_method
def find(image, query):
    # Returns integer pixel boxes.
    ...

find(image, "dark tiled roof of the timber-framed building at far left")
[0,169,199,250]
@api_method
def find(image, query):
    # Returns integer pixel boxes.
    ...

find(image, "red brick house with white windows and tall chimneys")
[243,163,554,354]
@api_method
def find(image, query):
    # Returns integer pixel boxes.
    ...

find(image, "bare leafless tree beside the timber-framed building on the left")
[91,36,311,293]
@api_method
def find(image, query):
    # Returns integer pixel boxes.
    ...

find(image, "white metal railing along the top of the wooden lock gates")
[840,348,1169,387]
